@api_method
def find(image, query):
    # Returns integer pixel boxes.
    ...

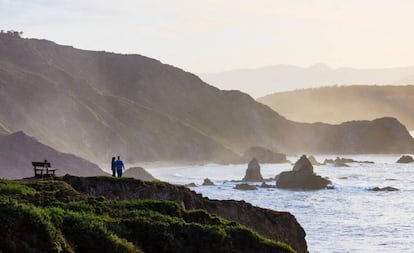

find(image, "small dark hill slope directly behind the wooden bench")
[0,132,106,179]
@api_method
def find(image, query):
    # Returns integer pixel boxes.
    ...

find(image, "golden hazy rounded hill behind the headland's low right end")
[258,85,414,130]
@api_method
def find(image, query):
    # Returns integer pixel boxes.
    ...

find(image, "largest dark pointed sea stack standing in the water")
[276,155,330,189]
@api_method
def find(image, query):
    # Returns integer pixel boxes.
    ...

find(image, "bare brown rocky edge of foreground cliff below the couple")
[62,175,307,253]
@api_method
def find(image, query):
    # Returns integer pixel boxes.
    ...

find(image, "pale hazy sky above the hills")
[0,0,414,73]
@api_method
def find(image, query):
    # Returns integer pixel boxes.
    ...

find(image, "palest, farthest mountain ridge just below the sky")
[200,64,414,98]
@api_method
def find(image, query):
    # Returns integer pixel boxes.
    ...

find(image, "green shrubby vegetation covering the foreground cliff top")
[0,179,293,253]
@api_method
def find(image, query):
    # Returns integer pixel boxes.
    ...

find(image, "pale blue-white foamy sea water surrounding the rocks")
[148,155,414,253]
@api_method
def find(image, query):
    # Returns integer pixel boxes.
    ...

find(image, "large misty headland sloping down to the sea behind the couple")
[0,33,414,164]
